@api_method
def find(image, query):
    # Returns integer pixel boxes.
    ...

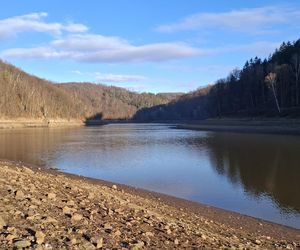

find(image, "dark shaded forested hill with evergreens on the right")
[135,40,300,121]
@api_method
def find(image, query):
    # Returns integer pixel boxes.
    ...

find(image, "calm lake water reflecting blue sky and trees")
[0,124,300,229]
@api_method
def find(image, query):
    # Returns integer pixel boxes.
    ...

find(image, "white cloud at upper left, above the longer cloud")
[0,12,88,39]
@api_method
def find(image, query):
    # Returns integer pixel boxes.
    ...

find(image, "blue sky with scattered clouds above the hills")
[0,0,300,93]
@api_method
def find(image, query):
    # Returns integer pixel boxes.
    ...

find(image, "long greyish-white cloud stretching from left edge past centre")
[0,34,202,63]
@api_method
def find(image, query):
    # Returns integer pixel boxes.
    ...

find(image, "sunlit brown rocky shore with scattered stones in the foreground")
[0,162,300,249]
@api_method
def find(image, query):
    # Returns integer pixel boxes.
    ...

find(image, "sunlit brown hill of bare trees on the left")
[0,61,180,120]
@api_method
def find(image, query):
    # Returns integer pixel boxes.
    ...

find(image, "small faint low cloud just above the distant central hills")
[95,72,147,83]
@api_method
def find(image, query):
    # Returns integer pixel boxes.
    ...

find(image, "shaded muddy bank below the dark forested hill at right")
[176,119,300,135]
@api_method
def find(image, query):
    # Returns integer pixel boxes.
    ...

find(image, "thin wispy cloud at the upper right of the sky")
[156,6,300,34]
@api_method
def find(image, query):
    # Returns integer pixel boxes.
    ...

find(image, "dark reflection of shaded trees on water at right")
[185,133,300,211]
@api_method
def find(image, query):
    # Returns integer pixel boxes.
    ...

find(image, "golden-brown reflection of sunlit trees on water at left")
[0,128,74,166]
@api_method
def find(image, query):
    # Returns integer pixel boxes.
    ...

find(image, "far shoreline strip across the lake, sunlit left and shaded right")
[0,118,300,135]
